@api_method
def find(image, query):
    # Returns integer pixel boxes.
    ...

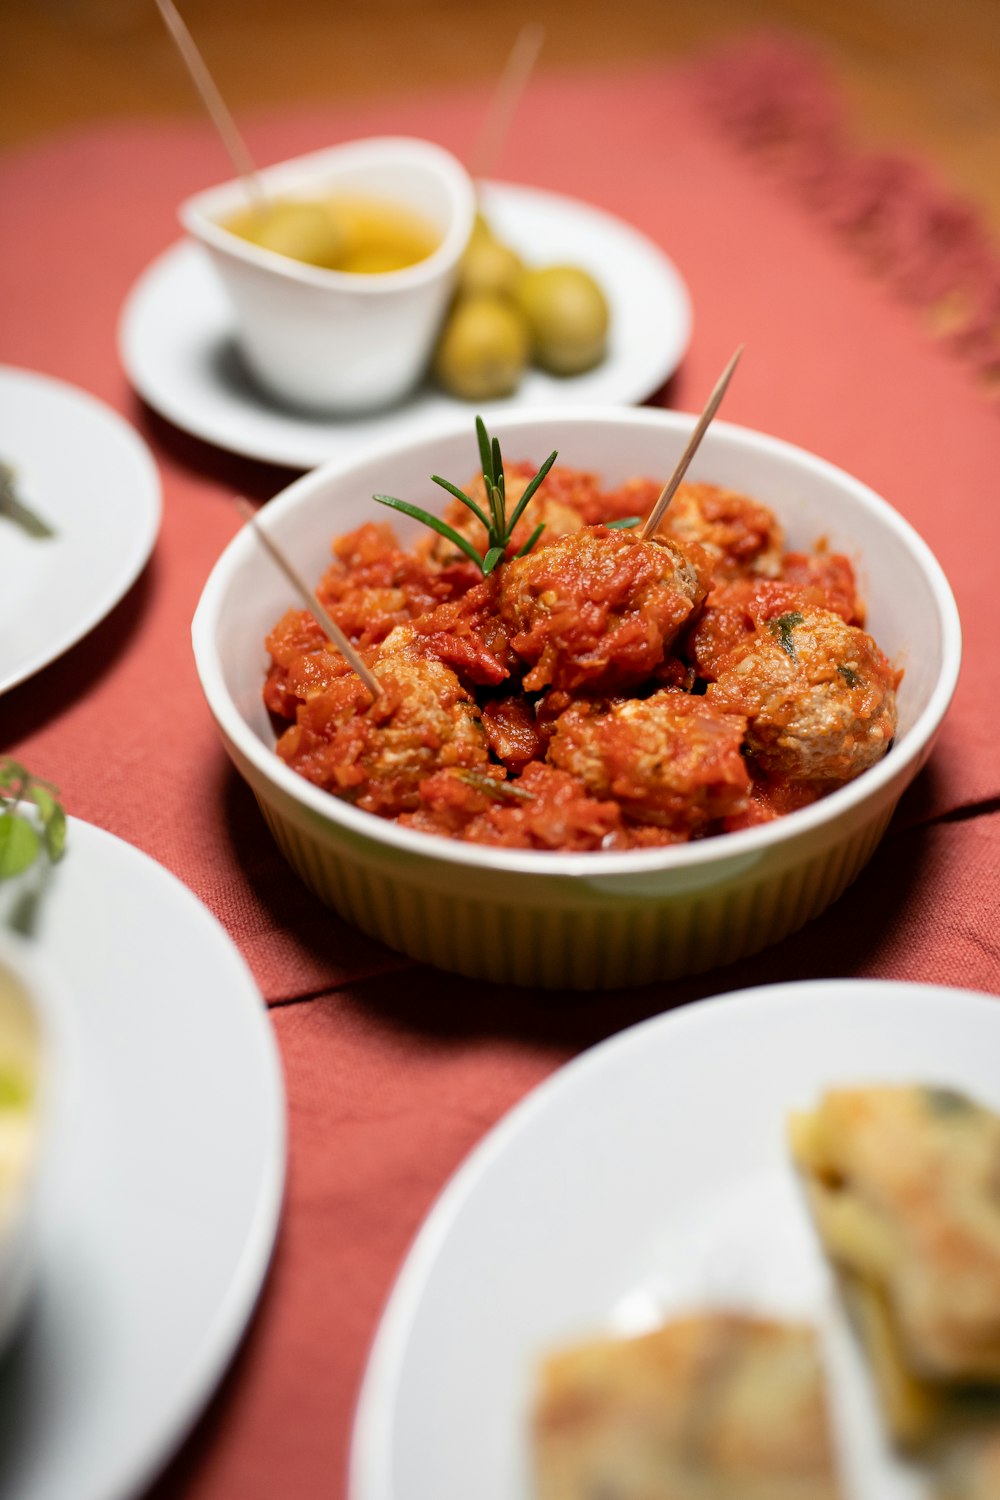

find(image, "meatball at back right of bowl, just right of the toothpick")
[658,485,783,579]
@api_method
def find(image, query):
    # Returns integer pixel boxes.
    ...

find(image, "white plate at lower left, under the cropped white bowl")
[0,819,285,1500]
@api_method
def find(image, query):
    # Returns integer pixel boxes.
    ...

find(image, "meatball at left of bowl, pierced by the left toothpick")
[277,626,487,818]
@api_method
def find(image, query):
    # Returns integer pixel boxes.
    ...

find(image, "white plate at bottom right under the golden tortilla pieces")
[351,980,1000,1500]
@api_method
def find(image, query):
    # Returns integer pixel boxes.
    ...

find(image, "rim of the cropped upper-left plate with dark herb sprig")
[0,365,162,695]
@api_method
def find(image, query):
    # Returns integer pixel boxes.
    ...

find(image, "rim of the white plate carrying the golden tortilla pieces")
[348,978,1000,1500]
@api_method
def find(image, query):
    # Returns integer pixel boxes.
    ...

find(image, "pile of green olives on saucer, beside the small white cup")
[432,215,609,401]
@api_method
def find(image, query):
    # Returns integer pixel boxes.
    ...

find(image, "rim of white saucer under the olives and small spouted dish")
[118,182,693,470]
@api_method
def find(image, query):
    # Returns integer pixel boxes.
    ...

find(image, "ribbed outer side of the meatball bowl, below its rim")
[258,798,895,990]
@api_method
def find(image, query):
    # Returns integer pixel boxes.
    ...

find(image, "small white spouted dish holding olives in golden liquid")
[178,137,475,413]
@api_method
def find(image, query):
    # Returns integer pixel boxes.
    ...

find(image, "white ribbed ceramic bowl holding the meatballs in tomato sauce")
[193,408,961,989]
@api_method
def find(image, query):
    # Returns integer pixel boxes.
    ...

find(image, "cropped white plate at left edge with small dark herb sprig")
[0,366,160,693]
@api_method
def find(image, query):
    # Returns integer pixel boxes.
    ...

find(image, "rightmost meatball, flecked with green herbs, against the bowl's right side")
[705,605,901,785]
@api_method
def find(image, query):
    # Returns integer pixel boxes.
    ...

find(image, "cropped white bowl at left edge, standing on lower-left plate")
[0,930,67,1349]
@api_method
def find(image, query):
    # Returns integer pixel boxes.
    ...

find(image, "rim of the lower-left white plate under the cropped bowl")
[0,818,288,1500]
